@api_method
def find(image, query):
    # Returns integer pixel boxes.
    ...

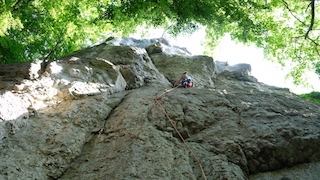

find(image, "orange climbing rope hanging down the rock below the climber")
[154,86,207,180]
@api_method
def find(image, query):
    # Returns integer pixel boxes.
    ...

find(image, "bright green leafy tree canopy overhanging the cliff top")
[0,0,320,84]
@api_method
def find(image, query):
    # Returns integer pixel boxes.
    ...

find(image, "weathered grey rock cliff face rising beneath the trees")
[0,38,320,180]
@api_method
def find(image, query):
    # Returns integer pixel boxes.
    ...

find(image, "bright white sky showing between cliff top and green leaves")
[133,29,320,94]
